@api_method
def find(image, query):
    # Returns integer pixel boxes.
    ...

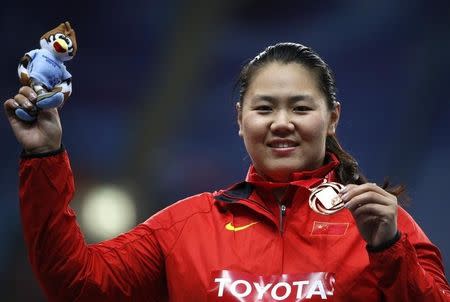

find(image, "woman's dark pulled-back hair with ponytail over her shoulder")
[236,43,404,195]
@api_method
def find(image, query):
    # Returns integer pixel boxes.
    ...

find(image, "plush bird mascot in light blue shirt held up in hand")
[15,22,77,122]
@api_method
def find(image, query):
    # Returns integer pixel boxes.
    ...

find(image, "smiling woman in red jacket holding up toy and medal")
[5,43,450,301]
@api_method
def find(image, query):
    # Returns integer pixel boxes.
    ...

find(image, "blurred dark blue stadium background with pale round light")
[0,0,450,301]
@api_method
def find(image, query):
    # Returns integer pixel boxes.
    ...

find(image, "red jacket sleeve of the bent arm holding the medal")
[369,208,450,302]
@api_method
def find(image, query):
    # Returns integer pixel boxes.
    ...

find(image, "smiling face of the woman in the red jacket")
[237,62,340,181]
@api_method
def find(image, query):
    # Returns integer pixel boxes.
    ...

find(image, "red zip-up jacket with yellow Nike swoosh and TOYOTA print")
[20,152,450,302]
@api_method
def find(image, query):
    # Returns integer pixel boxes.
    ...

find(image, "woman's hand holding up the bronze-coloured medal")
[340,183,397,247]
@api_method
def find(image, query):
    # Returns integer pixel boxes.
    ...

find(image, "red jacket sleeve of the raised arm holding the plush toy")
[19,151,167,301]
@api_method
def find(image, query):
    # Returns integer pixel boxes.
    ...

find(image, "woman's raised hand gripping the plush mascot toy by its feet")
[4,86,62,154]
